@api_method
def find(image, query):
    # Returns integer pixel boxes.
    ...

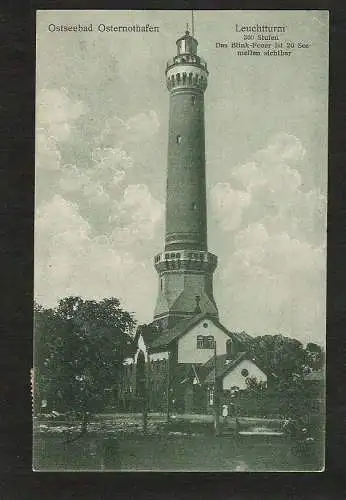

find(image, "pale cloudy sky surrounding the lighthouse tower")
[35,11,328,343]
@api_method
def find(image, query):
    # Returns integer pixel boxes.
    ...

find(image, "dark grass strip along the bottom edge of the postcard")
[34,433,321,471]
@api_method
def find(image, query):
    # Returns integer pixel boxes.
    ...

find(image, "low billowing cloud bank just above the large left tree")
[35,195,156,321]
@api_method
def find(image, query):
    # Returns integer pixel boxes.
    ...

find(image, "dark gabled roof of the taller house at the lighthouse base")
[150,313,251,351]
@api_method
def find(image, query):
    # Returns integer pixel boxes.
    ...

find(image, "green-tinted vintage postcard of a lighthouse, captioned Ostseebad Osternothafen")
[31,10,329,472]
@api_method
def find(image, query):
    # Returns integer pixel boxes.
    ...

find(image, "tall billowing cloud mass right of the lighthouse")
[211,133,326,341]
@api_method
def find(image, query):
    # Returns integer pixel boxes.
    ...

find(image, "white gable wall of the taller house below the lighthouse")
[178,319,229,363]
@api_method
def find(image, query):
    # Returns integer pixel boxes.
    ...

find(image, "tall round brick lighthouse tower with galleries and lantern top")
[154,31,218,328]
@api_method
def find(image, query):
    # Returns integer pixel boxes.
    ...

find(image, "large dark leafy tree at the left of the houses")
[35,297,135,433]
